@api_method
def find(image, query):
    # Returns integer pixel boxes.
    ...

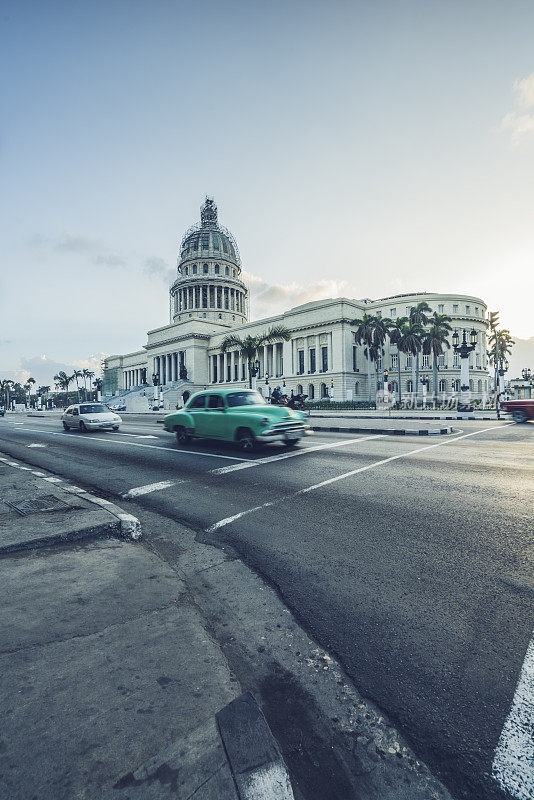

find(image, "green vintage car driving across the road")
[163,389,310,450]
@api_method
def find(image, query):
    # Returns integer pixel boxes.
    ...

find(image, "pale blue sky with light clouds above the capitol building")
[0,0,534,384]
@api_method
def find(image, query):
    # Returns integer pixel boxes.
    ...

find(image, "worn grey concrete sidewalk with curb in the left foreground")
[0,459,293,800]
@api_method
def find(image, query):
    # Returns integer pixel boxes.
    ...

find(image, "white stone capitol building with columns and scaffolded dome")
[103,198,489,411]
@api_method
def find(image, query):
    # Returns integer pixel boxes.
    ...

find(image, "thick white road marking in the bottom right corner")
[492,638,534,800]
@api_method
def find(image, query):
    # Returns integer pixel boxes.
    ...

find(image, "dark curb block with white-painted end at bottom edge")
[216,692,294,800]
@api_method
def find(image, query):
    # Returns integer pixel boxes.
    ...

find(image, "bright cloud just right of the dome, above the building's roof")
[243,272,352,317]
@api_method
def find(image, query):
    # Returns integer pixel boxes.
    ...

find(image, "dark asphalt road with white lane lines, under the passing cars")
[0,415,534,800]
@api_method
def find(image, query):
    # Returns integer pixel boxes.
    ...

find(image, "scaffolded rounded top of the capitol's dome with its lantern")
[178,197,241,272]
